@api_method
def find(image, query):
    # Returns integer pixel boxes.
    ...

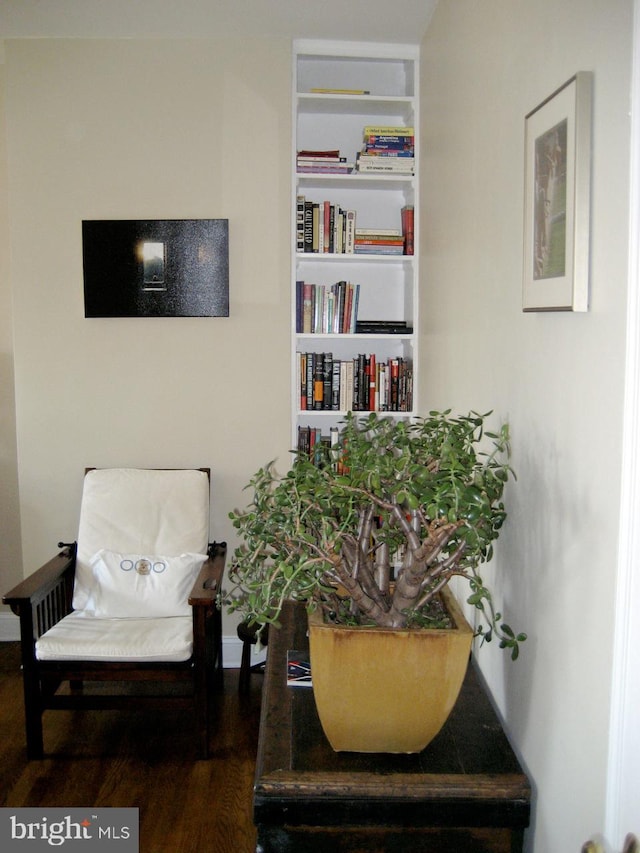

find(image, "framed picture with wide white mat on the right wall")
[522,71,592,311]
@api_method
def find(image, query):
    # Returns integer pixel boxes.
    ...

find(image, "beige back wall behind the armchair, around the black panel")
[0,39,291,630]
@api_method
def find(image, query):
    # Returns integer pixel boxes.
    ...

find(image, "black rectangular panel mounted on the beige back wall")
[82,219,229,317]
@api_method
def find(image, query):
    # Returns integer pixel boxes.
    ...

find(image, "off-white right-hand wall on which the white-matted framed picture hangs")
[421,0,632,853]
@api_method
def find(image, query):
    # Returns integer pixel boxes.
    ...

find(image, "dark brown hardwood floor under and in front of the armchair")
[0,643,262,853]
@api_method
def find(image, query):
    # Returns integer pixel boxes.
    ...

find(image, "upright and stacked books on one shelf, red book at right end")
[296,195,414,255]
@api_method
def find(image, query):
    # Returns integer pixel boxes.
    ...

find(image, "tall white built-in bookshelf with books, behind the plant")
[291,40,419,447]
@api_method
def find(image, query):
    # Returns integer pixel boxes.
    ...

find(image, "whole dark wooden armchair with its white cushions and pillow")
[3,468,226,758]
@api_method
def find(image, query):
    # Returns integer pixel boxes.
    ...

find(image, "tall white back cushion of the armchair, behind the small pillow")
[73,468,209,612]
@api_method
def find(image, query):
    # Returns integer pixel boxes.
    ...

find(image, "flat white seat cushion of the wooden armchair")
[36,611,193,663]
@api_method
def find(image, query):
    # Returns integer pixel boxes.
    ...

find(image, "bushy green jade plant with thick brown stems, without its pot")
[225,411,526,659]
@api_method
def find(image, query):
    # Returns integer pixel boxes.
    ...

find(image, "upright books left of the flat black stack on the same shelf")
[296,281,360,335]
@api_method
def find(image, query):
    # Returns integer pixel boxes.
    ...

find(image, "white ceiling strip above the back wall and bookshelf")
[0,0,438,44]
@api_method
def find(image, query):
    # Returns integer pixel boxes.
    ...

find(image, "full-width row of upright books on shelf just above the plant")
[297,352,413,412]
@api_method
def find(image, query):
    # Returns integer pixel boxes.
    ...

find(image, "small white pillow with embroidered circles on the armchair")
[90,548,207,619]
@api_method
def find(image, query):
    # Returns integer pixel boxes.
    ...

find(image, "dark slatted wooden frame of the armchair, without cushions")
[2,472,227,759]
